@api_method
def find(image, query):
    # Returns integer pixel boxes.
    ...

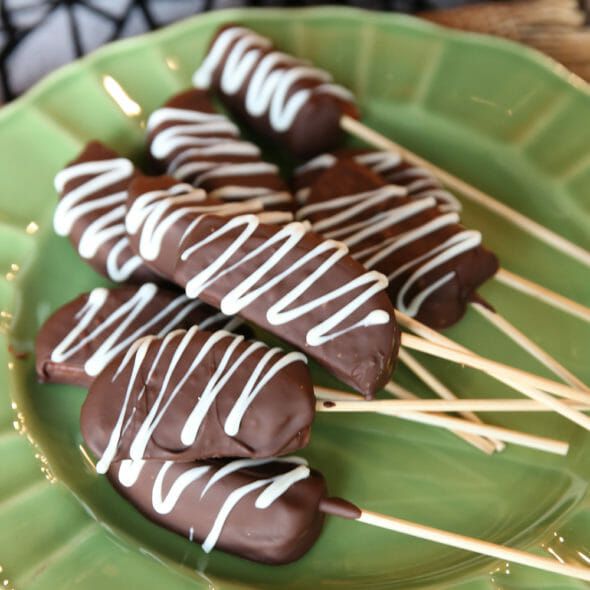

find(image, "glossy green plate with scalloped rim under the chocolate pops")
[0,8,590,590]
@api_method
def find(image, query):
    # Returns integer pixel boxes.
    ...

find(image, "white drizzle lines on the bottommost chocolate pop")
[118,456,311,553]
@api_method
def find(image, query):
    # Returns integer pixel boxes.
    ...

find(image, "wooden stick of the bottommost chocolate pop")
[344,508,590,580]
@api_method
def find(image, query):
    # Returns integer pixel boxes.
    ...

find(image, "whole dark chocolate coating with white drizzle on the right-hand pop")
[297,159,498,328]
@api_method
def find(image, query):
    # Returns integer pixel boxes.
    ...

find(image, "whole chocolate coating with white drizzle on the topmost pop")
[193,25,359,158]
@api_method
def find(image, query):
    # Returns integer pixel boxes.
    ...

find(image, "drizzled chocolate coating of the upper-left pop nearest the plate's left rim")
[55,141,160,283]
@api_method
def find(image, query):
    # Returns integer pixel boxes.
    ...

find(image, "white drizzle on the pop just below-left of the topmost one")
[148,107,292,206]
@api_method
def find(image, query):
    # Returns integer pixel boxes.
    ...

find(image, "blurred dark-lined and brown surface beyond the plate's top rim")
[0,0,590,102]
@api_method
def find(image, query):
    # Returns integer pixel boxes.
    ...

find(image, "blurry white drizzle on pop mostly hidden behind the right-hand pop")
[295,151,461,213]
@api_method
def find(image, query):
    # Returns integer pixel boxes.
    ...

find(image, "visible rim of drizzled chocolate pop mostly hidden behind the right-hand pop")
[292,148,461,212]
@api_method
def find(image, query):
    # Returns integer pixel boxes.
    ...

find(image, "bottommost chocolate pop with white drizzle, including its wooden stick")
[102,456,590,580]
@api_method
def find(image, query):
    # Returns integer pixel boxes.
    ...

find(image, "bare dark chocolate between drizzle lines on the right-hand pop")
[298,159,498,328]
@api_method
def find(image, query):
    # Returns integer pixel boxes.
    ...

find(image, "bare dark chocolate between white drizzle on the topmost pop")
[194,25,359,158]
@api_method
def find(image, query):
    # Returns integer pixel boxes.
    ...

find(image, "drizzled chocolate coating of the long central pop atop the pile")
[127,178,399,397]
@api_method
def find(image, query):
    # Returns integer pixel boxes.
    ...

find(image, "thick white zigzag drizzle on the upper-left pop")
[53,158,142,282]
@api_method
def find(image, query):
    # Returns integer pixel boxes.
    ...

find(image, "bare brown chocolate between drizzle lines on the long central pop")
[127,177,399,397]
